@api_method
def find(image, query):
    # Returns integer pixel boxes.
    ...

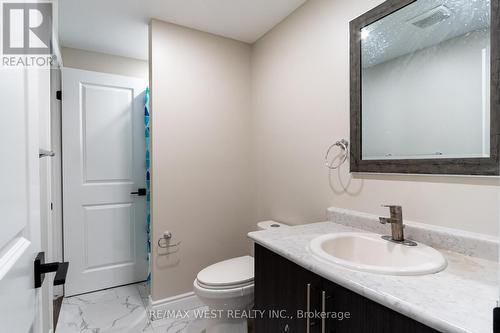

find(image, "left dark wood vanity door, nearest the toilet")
[255,245,321,333]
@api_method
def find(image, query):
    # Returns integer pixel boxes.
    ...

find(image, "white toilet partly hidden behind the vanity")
[193,221,288,333]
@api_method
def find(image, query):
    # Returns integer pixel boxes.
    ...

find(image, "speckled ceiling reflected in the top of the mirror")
[361,0,490,67]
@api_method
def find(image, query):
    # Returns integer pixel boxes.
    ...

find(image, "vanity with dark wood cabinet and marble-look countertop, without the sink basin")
[249,208,498,333]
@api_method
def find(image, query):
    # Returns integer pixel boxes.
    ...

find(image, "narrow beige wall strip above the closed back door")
[61,47,149,79]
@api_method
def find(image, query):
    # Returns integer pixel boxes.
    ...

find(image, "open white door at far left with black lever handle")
[0,69,51,333]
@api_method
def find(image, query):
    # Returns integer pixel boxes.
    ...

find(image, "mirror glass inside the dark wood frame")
[361,0,490,160]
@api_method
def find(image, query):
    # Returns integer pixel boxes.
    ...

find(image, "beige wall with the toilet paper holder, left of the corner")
[150,21,255,300]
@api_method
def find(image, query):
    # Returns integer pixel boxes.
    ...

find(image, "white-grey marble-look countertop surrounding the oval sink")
[248,222,498,333]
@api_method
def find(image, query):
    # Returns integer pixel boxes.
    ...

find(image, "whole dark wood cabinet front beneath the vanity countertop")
[255,244,437,333]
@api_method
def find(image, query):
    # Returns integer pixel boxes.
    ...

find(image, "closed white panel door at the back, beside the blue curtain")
[62,68,147,296]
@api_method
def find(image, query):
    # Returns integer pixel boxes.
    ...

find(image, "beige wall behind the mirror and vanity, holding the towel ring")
[252,0,499,235]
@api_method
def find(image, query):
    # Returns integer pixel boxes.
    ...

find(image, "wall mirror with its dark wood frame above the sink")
[350,0,500,175]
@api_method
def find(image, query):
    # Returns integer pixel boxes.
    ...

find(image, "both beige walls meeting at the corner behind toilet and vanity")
[150,0,499,300]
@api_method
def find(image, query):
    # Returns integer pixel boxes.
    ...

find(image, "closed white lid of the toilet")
[197,256,254,287]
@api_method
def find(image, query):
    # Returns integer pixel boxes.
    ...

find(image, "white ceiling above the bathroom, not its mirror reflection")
[59,0,306,59]
